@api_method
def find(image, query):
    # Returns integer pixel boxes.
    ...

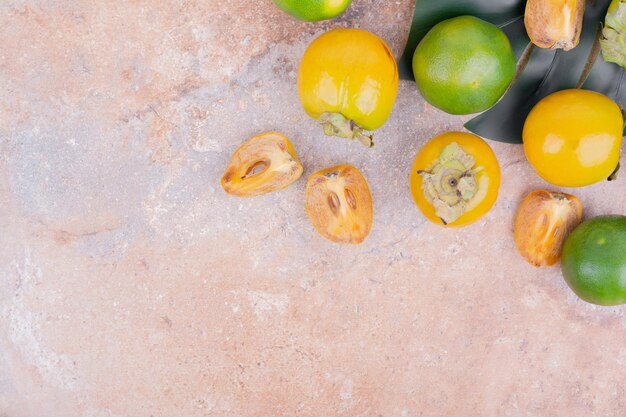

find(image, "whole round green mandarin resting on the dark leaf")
[413,16,516,114]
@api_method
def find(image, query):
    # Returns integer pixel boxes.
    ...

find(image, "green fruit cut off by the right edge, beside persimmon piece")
[561,216,626,306]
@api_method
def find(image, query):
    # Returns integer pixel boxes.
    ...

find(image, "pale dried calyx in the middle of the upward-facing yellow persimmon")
[418,142,478,224]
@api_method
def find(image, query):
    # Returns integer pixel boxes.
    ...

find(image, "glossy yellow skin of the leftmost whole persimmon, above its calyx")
[298,29,398,130]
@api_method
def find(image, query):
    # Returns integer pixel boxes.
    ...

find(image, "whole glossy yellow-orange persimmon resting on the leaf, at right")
[523,90,624,187]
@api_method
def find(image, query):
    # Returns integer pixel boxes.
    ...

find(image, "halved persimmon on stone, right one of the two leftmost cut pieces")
[306,165,374,243]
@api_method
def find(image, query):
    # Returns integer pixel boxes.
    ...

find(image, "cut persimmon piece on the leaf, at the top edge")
[524,0,585,51]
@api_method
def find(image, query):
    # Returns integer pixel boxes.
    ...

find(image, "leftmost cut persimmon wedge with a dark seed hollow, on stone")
[222,132,304,197]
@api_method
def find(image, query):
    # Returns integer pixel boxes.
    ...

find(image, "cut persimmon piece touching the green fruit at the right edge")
[514,190,583,266]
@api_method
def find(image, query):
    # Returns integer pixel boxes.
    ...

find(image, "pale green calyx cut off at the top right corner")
[600,0,626,68]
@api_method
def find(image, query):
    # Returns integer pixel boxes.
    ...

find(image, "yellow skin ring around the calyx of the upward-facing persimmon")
[409,132,500,227]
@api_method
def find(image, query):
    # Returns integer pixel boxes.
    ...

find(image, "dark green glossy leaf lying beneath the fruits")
[399,0,626,143]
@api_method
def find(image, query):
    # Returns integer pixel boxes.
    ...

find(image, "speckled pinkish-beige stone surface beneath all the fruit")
[0,0,626,417]
